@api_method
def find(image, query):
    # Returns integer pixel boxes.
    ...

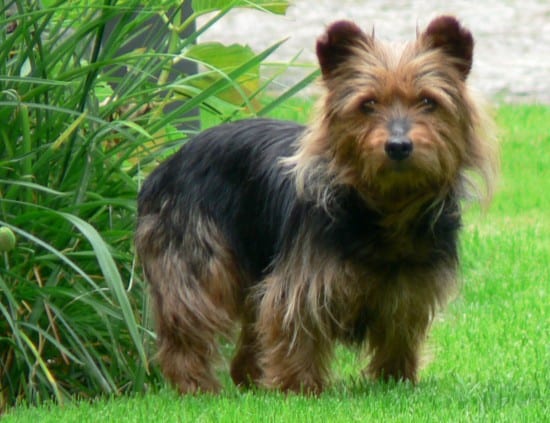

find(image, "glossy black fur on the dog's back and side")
[138,119,304,278]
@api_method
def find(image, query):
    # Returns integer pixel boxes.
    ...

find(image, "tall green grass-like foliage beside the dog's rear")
[0,0,320,413]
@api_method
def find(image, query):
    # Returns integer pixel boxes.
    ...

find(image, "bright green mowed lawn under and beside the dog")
[2,101,550,423]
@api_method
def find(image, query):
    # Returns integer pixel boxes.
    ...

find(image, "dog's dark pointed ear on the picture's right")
[421,16,474,80]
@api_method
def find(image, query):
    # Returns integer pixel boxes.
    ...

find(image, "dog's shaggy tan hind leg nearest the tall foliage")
[136,216,240,393]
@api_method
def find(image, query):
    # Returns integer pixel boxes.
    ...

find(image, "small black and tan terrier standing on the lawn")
[136,16,498,393]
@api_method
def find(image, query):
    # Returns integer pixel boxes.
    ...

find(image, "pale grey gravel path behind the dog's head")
[202,0,550,104]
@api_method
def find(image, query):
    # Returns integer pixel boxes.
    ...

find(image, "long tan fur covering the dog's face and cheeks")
[283,29,499,215]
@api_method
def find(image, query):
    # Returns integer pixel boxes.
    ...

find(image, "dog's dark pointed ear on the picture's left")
[317,21,370,79]
